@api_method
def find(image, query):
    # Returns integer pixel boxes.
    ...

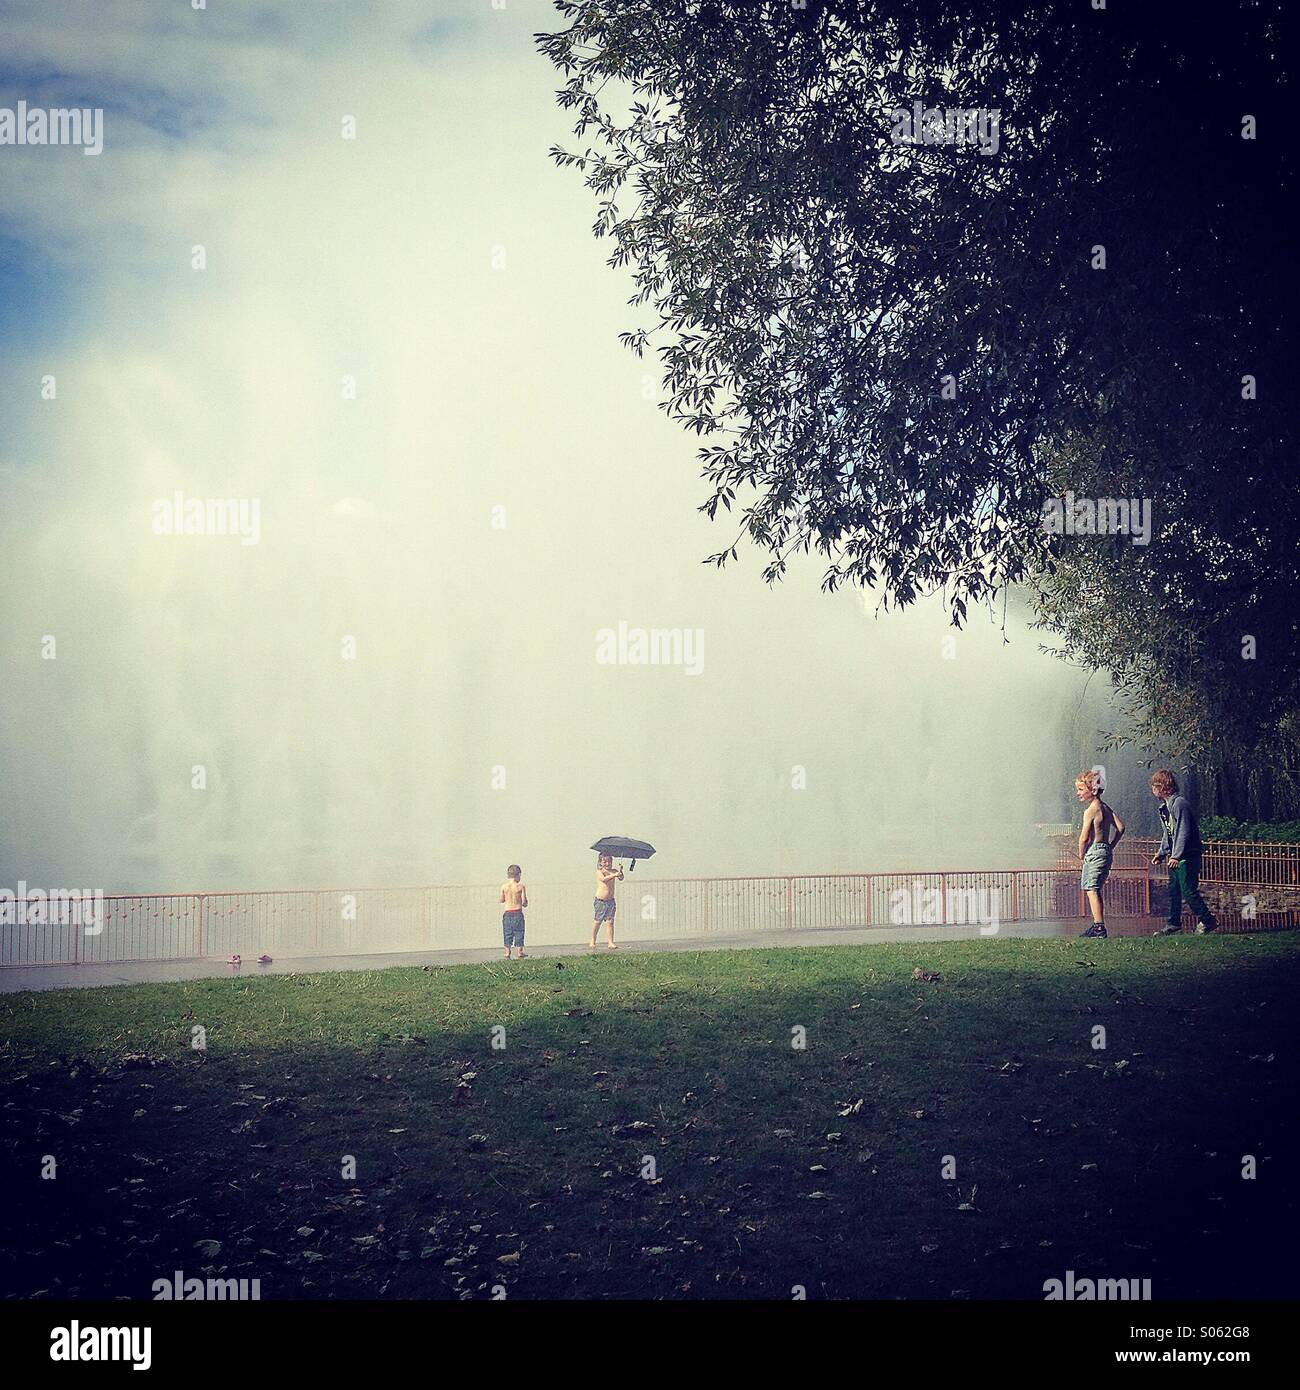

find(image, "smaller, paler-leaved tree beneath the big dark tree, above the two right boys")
[1034,419,1300,820]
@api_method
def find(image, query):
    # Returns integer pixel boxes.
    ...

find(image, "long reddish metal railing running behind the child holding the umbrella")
[0,855,1167,967]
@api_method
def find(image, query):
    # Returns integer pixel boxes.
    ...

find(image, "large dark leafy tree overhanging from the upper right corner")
[538,0,1296,806]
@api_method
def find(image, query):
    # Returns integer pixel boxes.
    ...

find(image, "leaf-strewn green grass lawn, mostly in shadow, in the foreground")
[0,933,1300,1300]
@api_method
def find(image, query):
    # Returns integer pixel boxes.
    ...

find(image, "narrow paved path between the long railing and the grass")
[0,917,1201,994]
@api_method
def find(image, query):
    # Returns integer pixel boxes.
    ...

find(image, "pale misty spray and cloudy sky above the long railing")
[0,0,1123,892]
